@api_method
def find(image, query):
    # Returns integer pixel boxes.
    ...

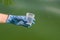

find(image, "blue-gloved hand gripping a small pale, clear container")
[7,13,35,28]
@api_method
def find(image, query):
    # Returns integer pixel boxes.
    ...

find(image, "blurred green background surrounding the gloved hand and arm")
[0,0,60,40]
